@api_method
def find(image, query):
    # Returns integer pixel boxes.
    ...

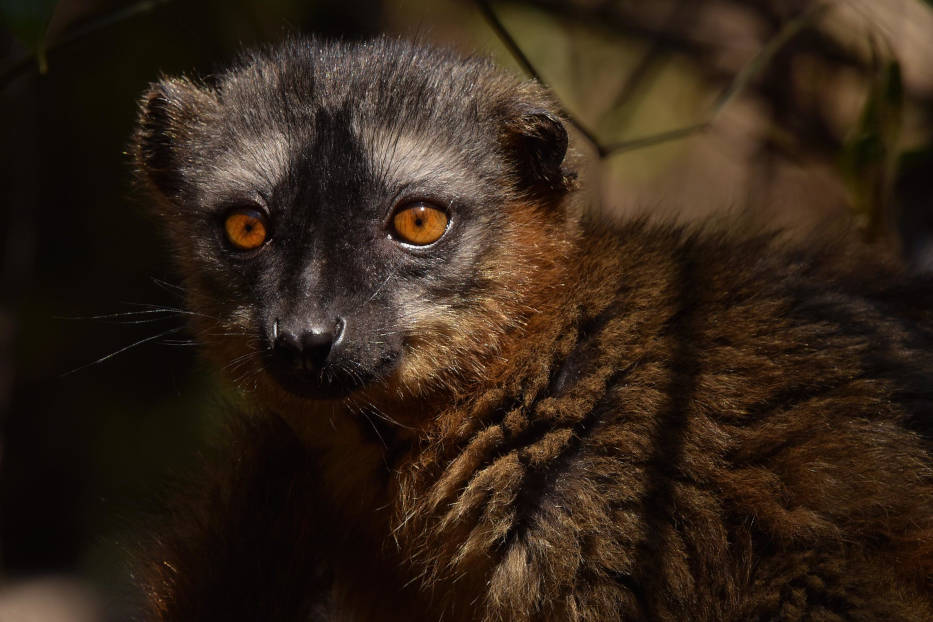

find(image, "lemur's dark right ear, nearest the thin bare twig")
[504,108,574,198]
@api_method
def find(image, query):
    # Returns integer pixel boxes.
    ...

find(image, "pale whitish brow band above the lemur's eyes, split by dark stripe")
[203,88,499,210]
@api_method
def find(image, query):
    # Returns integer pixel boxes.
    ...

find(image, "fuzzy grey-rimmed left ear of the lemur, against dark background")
[133,78,217,198]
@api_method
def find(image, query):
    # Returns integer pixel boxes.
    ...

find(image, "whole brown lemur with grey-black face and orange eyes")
[132,37,933,622]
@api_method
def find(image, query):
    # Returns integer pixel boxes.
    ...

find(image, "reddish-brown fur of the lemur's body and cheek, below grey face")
[133,36,933,622]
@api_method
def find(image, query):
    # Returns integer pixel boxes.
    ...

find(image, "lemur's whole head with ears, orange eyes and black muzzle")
[133,39,574,410]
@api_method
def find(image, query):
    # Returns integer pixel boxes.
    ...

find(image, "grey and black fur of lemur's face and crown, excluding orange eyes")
[137,40,572,400]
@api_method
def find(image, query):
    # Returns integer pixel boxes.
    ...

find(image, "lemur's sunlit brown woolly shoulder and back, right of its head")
[395,222,933,620]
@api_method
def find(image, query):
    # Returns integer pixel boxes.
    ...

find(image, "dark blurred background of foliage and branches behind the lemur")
[0,0,933,622]
